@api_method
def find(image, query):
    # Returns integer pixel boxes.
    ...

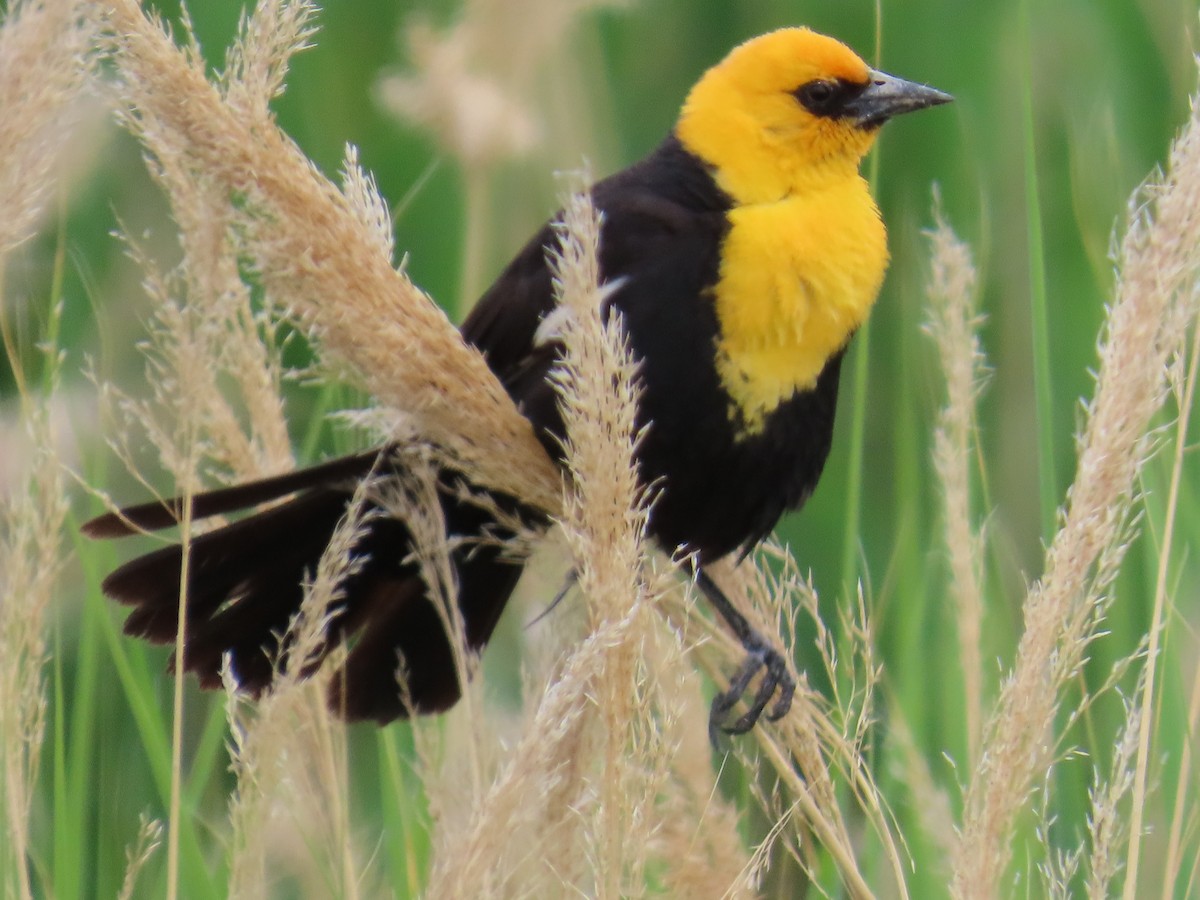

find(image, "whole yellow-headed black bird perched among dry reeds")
[83,26,952,736]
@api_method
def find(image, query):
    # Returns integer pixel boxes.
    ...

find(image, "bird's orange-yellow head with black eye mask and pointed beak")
[676,28,950,203]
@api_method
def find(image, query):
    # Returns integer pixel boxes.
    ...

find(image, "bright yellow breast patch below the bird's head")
[714,174,888,434]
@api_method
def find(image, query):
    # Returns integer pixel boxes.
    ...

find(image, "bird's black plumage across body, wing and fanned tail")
[85,137,841,722]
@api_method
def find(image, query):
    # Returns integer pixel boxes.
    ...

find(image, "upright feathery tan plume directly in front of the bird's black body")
[551,192,665,898]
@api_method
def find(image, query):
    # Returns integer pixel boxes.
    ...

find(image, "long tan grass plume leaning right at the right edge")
[952,60,1200,898]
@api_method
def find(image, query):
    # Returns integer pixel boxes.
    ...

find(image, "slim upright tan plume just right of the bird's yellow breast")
[926,204,985,770]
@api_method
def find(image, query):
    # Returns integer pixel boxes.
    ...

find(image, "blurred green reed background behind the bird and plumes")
[0,0,1200,898]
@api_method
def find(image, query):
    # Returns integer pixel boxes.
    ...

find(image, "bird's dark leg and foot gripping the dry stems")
[696,569,796,746]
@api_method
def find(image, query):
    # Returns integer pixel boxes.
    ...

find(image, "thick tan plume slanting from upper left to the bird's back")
[99,0,559,509]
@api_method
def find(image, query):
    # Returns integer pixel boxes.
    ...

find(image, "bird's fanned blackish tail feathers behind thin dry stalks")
[91,451,535,722]
